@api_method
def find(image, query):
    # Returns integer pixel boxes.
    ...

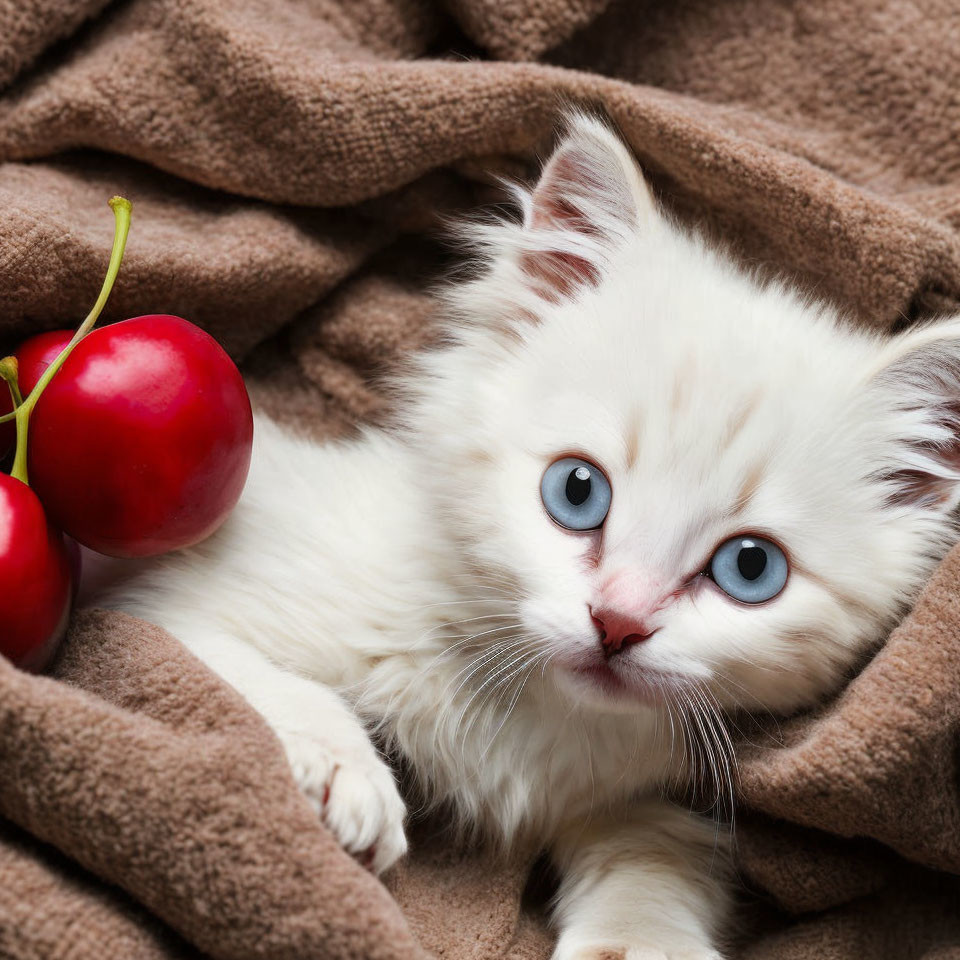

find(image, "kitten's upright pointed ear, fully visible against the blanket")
[520,113,656,300]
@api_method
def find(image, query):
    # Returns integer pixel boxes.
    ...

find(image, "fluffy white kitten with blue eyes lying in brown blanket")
[97,116,960,960]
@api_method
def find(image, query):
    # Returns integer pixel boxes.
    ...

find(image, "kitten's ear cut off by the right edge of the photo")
[873,317,960,512]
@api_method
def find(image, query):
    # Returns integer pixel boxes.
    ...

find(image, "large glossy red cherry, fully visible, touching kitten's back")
[27,315,253,557]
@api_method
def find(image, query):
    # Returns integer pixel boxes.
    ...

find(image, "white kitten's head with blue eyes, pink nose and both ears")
[416,116,960,710]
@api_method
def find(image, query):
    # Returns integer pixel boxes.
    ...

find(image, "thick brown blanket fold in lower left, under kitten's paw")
[0,611,425,960]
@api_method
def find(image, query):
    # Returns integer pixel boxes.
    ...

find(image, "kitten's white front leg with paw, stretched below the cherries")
[178,631,407,873]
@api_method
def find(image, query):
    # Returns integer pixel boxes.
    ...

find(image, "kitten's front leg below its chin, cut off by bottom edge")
[553,800,728,960]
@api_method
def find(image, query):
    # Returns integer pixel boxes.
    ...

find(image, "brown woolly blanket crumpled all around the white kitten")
[0,0,960,960]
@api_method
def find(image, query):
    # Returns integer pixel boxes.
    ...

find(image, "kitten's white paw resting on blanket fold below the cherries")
[277,730,407,873]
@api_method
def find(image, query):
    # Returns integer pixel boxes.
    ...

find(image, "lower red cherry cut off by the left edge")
[0,474,72,670]
